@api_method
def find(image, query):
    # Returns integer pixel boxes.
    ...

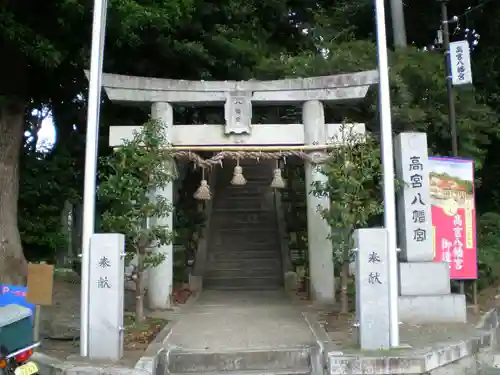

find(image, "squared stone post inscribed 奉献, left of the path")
[89,233,125,361]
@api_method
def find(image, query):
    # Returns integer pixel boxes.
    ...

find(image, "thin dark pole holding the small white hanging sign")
[441,0,465,294]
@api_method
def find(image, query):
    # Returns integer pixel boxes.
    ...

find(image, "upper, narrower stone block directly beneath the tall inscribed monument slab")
[399,262,450,296]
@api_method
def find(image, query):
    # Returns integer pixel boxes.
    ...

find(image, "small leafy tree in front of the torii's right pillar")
[313,126,383,313]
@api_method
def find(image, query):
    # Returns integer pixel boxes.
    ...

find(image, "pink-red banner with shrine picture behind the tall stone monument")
[429,157,477,280]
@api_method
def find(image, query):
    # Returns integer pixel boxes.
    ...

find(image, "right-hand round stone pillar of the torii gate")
[302,100,335,303]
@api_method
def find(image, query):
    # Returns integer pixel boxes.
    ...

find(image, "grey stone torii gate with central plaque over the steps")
[103,70,378,309]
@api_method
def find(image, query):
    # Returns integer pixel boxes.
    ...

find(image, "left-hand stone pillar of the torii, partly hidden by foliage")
[148,102,174,309]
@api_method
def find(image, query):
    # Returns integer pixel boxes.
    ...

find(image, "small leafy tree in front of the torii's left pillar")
[98,120,173,322]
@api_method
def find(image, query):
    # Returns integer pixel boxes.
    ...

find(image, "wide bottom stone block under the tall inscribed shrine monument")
[399,294,467,323]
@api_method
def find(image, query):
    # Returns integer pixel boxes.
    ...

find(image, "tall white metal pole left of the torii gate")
[80,0,107,357]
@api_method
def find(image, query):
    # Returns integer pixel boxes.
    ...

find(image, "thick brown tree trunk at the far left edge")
[0,96,27,285]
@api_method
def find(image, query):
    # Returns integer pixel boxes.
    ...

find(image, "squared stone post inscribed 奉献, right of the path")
[354,228,391,350]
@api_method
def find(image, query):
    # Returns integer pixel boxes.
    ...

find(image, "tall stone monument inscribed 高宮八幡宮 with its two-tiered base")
[394,133,467,322]
